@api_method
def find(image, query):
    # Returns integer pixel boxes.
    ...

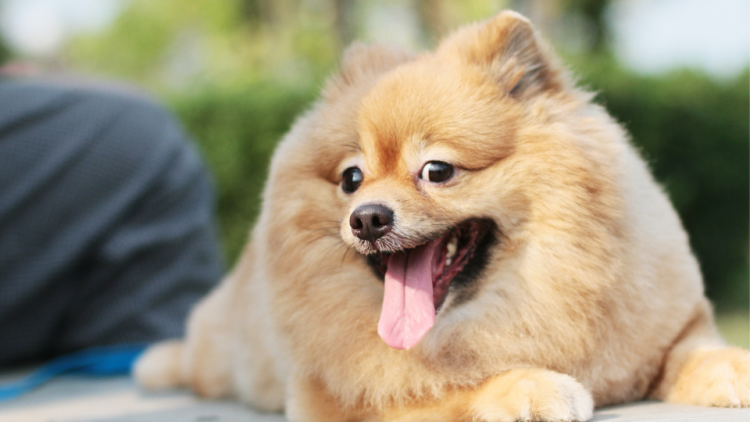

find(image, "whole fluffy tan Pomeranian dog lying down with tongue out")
[134,12,750,422]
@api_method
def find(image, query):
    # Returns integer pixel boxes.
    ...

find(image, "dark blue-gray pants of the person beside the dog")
[0,80,222,366]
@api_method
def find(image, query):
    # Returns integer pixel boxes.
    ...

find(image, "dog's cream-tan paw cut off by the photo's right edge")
[665,347,750,407]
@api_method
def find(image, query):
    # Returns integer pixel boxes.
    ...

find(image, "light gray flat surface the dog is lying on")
[0,374,750,422]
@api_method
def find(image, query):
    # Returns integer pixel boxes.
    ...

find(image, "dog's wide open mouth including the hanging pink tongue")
[369,220,491,349]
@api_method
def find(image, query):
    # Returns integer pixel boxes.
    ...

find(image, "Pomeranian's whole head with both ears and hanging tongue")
[270,12,616,348]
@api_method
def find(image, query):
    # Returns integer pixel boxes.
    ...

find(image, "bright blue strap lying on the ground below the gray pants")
[0,344,147,402]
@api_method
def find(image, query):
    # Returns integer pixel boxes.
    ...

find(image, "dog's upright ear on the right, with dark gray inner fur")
[438,11,565,99]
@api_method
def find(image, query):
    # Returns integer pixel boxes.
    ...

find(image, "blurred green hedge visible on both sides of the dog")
[170,66,750,309]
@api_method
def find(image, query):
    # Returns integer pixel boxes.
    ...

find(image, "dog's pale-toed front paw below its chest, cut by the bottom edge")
[472,369,594,422]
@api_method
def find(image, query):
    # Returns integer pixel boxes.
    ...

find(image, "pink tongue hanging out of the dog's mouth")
[378,239,441,349]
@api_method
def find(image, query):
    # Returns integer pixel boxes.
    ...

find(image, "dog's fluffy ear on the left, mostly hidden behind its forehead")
[324,42,414,98]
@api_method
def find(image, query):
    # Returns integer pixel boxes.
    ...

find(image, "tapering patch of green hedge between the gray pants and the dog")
[169,82,315,263]
